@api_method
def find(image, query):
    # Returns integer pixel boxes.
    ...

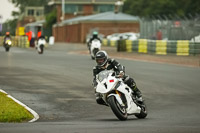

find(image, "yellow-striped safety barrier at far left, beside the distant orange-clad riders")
[0,36,30,48]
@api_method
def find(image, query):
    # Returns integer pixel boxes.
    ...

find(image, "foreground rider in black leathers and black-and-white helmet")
[93,51,143,105]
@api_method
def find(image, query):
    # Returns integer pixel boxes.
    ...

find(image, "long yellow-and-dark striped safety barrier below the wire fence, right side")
[103,39,200,55]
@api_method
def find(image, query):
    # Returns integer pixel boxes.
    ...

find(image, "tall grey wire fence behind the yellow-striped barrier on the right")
[140,15,200,40]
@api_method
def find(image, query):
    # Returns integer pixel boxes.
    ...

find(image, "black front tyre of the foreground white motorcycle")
[107,96,128,121]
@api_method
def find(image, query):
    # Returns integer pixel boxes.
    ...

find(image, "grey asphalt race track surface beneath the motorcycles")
[0,44,200,133]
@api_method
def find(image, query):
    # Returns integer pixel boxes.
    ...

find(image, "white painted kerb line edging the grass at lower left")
[0,89,39,122]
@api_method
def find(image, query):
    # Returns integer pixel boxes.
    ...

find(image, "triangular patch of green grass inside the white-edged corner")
[0,92,34,122]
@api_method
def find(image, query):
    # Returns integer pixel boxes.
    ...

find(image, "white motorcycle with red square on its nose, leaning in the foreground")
[96,70,147,120]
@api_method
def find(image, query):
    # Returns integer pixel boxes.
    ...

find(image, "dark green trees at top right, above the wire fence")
[123,0,200,17]
